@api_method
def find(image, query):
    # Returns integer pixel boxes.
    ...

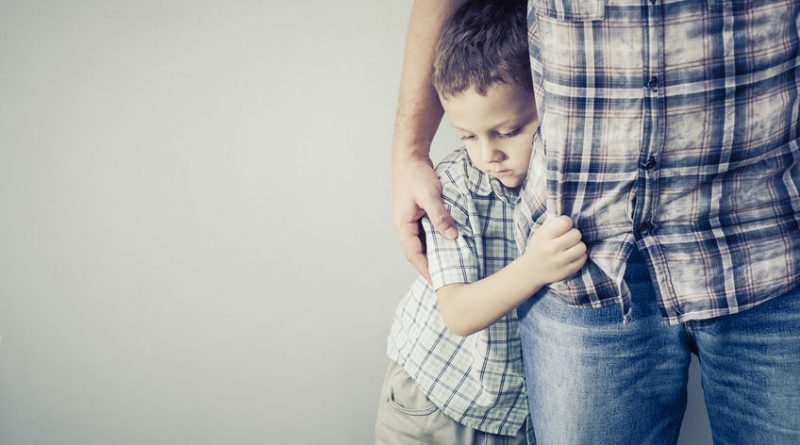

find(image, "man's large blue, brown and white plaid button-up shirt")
[515,0,800,324]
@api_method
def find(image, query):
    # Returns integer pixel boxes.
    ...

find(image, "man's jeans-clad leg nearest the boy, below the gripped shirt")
[519,250,690,445]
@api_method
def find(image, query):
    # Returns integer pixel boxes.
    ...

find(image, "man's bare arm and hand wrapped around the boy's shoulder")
[392,0,465,281]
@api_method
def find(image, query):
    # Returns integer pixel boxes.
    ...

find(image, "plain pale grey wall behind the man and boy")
[0,0,710,445]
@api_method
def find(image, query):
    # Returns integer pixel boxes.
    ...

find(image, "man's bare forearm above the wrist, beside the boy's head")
[392,0,465,162]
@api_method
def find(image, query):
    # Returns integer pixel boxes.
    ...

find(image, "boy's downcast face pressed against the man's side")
[440,82,539,188]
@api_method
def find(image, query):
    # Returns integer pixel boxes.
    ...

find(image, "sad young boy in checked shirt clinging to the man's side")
[376,0,586,445]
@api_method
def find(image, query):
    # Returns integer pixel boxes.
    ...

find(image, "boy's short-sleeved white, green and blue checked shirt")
[387,148,528,435]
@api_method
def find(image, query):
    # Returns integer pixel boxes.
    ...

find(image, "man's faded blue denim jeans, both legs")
[518,253,800,445]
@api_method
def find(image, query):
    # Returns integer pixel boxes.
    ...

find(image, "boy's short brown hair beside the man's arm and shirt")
[432,0,533,98]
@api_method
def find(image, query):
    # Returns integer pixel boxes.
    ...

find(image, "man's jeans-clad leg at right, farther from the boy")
[687,288,800,445]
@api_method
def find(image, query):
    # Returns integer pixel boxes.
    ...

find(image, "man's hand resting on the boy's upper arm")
[392,159,458,282]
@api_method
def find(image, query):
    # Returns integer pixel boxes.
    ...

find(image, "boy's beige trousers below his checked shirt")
[375,361,528,445]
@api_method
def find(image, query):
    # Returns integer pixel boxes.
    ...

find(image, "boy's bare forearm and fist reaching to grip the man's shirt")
[436,216,587,336]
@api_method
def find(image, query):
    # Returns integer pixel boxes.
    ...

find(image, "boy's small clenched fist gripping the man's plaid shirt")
[523,216,588,286]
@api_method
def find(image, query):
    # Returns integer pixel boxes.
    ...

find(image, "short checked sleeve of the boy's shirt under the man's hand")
[422,179,479,290]
